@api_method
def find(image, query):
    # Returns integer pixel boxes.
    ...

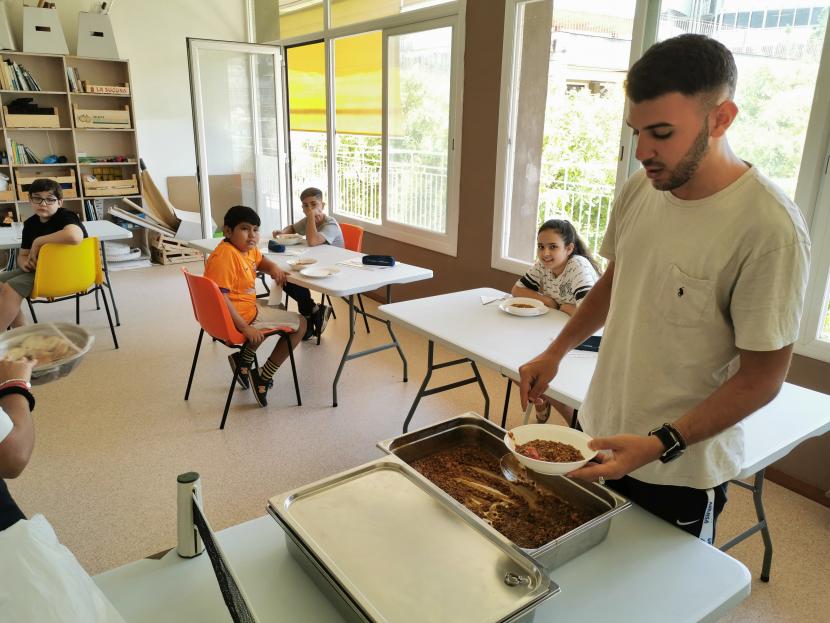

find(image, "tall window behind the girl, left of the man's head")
[493,0,636,274]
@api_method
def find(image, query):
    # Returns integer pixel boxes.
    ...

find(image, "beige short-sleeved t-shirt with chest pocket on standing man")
[579,167,810,489]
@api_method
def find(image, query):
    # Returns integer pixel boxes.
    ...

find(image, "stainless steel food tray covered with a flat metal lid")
[268,456,559,623]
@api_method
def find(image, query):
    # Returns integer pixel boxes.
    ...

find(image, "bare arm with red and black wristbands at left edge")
[0,360,35,478]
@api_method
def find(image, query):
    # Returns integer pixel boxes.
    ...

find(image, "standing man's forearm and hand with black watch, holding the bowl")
[568,344,793,480]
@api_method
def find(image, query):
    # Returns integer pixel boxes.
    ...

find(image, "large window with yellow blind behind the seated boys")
[281,0,463,255]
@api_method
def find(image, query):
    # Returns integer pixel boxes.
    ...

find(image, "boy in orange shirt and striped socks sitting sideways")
[205,206,306,407]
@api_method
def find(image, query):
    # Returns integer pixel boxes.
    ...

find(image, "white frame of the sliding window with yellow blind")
[277,0,466,257]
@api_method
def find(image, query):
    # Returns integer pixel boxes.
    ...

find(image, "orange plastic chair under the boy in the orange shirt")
[182,269,303,429]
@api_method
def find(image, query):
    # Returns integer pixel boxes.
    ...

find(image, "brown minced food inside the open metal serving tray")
[412,446,599,549]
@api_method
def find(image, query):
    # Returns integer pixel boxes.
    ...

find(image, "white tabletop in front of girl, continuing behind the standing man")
[379,288,830,478]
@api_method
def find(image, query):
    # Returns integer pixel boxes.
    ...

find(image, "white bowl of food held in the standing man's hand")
[504,424,597,476]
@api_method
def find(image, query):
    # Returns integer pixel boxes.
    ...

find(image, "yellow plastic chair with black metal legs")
[26,238,118,348]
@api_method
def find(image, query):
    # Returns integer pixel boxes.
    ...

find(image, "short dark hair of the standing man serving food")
[625,34,738,103]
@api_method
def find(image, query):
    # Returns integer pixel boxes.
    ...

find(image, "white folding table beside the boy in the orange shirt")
[188,238,432,407]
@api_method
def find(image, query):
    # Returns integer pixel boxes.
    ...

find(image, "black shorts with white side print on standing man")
[605,476,729,545]
